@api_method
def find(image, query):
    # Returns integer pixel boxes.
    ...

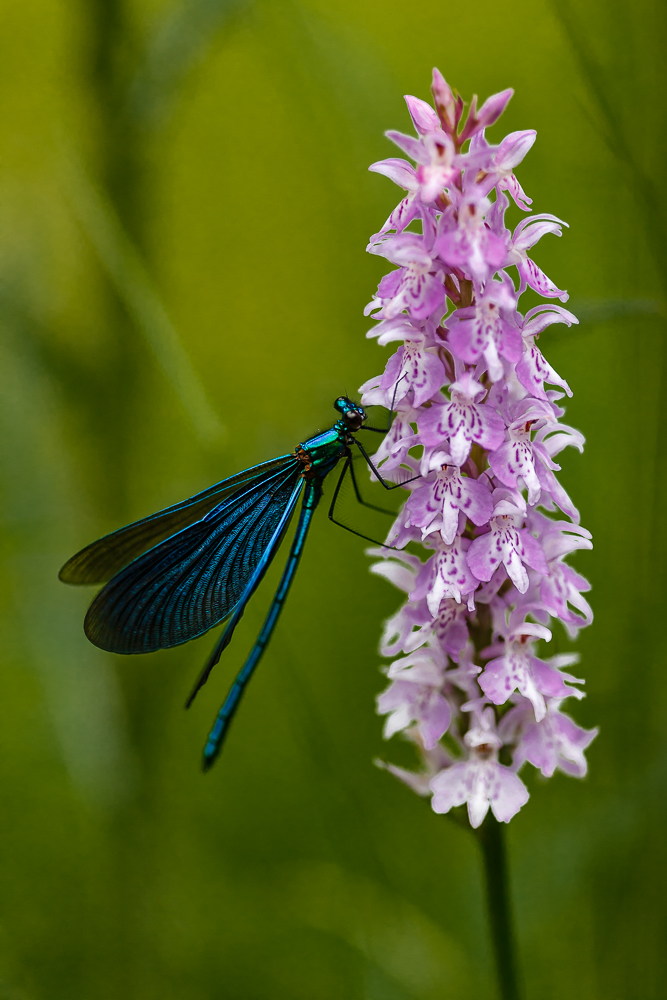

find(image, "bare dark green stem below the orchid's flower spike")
[476,811,522,1000]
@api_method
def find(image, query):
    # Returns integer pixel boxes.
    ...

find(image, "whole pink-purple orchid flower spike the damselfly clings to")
[361,69,597,827]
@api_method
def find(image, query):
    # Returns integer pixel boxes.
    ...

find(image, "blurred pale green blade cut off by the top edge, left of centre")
[127,0,247,128]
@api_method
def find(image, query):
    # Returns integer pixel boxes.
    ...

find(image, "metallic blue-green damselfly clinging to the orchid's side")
[60,396,414,770]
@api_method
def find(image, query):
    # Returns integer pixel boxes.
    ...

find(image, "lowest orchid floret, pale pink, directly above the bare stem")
[431,709,529,829]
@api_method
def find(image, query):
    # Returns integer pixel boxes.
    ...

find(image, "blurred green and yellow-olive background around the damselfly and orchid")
[0,0,667,1000]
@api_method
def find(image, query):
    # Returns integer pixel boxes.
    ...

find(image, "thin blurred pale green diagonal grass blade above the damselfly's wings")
[62,145,224,444]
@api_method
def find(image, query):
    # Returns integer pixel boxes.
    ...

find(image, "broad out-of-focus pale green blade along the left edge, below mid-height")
[0,322,134,804]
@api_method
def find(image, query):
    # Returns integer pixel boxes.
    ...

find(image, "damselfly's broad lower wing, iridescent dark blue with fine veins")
[84,456,303,653]
